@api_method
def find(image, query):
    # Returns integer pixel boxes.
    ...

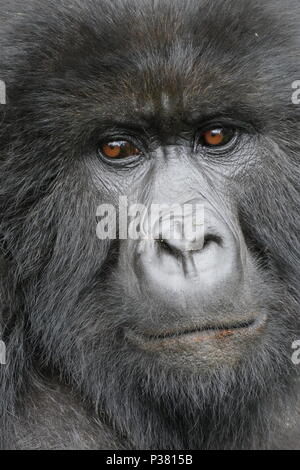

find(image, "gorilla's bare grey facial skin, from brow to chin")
[91,124,274,373]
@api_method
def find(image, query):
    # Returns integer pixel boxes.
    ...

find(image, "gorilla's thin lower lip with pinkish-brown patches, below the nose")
[126,314,267,350]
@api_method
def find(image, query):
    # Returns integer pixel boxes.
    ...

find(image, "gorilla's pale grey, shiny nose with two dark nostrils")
[136,208,242,299]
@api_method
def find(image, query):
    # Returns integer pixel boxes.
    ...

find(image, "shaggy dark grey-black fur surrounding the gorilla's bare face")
[0,0,300,449]
